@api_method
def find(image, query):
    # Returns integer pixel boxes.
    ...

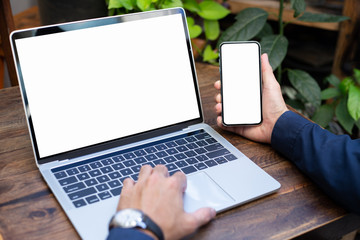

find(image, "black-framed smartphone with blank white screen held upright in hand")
[220,41,262,126]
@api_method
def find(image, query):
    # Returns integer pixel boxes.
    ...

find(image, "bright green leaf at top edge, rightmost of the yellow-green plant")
[198,1,230,20]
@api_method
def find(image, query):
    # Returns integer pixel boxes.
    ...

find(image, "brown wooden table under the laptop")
[0,63,358,240]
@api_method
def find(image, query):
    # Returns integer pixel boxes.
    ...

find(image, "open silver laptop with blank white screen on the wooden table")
[10,8,280,239]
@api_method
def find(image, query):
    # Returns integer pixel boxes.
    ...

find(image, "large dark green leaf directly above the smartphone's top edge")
[217,8,268,46]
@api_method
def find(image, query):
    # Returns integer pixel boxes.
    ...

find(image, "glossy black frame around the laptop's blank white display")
[10,8,203,165]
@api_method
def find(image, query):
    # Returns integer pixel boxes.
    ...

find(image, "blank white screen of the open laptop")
[11,10,201,158]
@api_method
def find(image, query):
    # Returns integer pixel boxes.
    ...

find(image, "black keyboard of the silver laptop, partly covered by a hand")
[52,130,237,208]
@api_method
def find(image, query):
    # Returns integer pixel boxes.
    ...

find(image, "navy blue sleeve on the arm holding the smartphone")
[271,111,360,213]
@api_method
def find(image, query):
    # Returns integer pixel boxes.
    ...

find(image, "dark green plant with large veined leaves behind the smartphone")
[218,0,348,116]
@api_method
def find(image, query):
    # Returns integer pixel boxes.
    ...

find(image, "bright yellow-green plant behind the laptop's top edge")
[106,0,230,63]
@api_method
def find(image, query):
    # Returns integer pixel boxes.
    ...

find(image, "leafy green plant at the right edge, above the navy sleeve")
[312,69,360,134]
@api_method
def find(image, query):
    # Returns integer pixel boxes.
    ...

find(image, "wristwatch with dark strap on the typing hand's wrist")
[109,208,164,240]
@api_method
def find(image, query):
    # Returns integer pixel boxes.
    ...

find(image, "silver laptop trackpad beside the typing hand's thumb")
[184,172,234,212]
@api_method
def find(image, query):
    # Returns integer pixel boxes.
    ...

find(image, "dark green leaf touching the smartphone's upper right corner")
[260,35,289,70]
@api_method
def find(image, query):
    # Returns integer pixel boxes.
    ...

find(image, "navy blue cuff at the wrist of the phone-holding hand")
[271,111,311,159]
